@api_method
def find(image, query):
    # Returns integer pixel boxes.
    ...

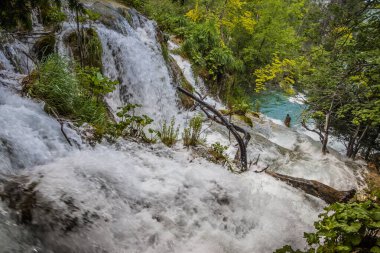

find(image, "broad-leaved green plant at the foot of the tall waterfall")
[116,104,153,142]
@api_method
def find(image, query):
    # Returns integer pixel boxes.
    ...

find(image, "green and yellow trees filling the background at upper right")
[128,0,380,160]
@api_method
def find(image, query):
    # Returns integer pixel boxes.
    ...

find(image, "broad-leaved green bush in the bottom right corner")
[276,201,380,253]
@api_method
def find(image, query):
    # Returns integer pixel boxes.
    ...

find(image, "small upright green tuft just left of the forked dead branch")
[182,115,203,147]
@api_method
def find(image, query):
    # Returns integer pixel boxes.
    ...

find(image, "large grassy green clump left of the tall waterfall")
[29,54,113,131]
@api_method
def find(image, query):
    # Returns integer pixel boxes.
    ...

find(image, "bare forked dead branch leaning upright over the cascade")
[177,87,251,171]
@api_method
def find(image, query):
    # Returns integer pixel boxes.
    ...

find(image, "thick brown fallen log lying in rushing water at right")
[265,171,356,204]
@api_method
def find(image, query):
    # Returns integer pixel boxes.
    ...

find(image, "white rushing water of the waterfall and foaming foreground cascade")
[0,4,364,253]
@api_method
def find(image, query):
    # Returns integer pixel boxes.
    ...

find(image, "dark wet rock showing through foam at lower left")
[0,176,100,233]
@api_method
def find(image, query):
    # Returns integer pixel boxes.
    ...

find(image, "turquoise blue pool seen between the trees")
[252,91,306,126]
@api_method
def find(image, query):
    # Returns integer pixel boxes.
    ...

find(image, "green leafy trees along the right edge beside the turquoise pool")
[300,0,380,159]
